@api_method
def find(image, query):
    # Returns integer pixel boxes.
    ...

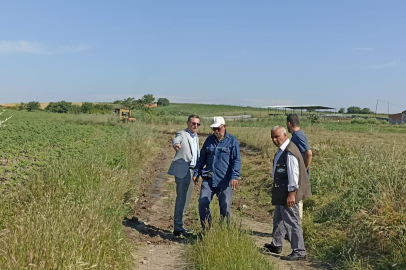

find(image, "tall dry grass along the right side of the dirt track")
[230,127,406,270]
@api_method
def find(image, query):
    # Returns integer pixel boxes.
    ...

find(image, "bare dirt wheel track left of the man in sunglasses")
[123,139,194,270]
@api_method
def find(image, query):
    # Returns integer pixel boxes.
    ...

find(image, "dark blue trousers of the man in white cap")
[199,179,233,229]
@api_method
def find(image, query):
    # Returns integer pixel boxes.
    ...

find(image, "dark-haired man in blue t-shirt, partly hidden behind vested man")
[286,114,313,220]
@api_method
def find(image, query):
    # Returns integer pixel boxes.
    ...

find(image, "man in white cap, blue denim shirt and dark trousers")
[193,116,241,229]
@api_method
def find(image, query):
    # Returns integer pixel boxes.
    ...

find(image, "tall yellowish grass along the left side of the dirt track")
[0,111,163,269]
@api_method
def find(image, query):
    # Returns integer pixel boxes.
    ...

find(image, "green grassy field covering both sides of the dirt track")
[0,104,406,270]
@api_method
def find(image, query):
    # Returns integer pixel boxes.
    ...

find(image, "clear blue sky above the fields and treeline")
[0,0,406,113]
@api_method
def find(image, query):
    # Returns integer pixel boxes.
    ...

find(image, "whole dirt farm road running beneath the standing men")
[123,138,328,270]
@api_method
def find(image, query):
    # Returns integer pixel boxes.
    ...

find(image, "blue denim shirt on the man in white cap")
[194,132,241,187]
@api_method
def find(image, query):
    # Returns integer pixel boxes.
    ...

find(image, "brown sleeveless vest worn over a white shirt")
[272,142,312,205]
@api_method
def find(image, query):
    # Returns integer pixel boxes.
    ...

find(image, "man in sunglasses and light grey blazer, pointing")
[168,114,200,237]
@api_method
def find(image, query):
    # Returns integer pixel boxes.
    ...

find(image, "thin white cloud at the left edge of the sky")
[0,40,90,54]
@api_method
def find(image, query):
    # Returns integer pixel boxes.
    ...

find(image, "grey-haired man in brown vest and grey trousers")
[264,126,311,261]
